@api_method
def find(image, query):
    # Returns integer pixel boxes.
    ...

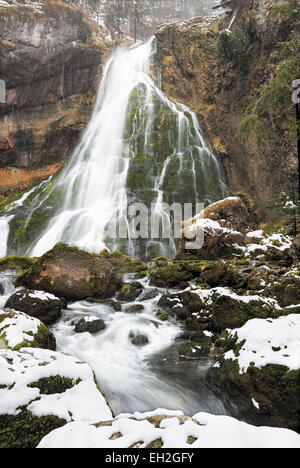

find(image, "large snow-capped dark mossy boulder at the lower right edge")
[207,315,300,432]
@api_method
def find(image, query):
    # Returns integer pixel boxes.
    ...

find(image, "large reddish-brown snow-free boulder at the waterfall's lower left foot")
[17,244,121,300]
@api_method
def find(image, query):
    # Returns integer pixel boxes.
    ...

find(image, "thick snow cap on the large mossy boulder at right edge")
[224,314,300,374]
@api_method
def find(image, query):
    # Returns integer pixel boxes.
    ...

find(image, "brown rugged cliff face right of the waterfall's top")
[156,0,297,213]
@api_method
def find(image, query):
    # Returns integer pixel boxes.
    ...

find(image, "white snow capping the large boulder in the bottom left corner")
[0,348,112,423]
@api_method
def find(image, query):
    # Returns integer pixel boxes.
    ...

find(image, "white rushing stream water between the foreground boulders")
[53,281,226,415]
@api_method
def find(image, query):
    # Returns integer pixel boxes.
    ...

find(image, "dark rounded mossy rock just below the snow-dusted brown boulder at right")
[200,260,244,288]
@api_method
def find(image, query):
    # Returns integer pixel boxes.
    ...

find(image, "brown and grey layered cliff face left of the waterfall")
[0,0,112,194]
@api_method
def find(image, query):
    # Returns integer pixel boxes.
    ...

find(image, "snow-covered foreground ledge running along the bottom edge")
[38,410,300,449]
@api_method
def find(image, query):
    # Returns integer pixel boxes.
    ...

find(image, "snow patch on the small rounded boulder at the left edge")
[0,310,42,349]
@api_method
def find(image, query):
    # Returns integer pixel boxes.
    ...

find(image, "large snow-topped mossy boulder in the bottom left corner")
[0,348,112,448]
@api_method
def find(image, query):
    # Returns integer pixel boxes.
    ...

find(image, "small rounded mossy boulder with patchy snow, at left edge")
[0,309,56,351]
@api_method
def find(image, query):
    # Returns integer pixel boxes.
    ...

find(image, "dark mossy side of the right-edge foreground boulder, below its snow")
[207,359,300,432]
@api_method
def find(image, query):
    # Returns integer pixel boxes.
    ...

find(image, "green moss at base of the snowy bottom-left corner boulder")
[0,410,67,448]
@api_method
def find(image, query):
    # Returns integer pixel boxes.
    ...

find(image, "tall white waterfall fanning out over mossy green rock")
[0,39,226,257]
